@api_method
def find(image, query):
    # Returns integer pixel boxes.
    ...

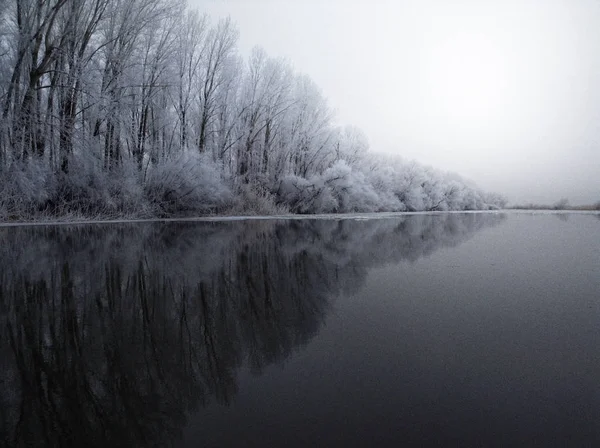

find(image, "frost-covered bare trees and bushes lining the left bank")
[0,0,505,219]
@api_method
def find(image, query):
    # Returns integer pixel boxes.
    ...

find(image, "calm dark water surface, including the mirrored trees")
[0,214,600,447]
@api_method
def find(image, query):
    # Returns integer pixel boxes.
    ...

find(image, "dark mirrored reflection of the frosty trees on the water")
[0,214,503,446]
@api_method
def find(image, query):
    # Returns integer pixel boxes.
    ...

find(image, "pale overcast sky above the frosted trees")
[189,0,600,204]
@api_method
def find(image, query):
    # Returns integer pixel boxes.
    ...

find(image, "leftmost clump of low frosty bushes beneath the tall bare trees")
[0,154,233,221]
